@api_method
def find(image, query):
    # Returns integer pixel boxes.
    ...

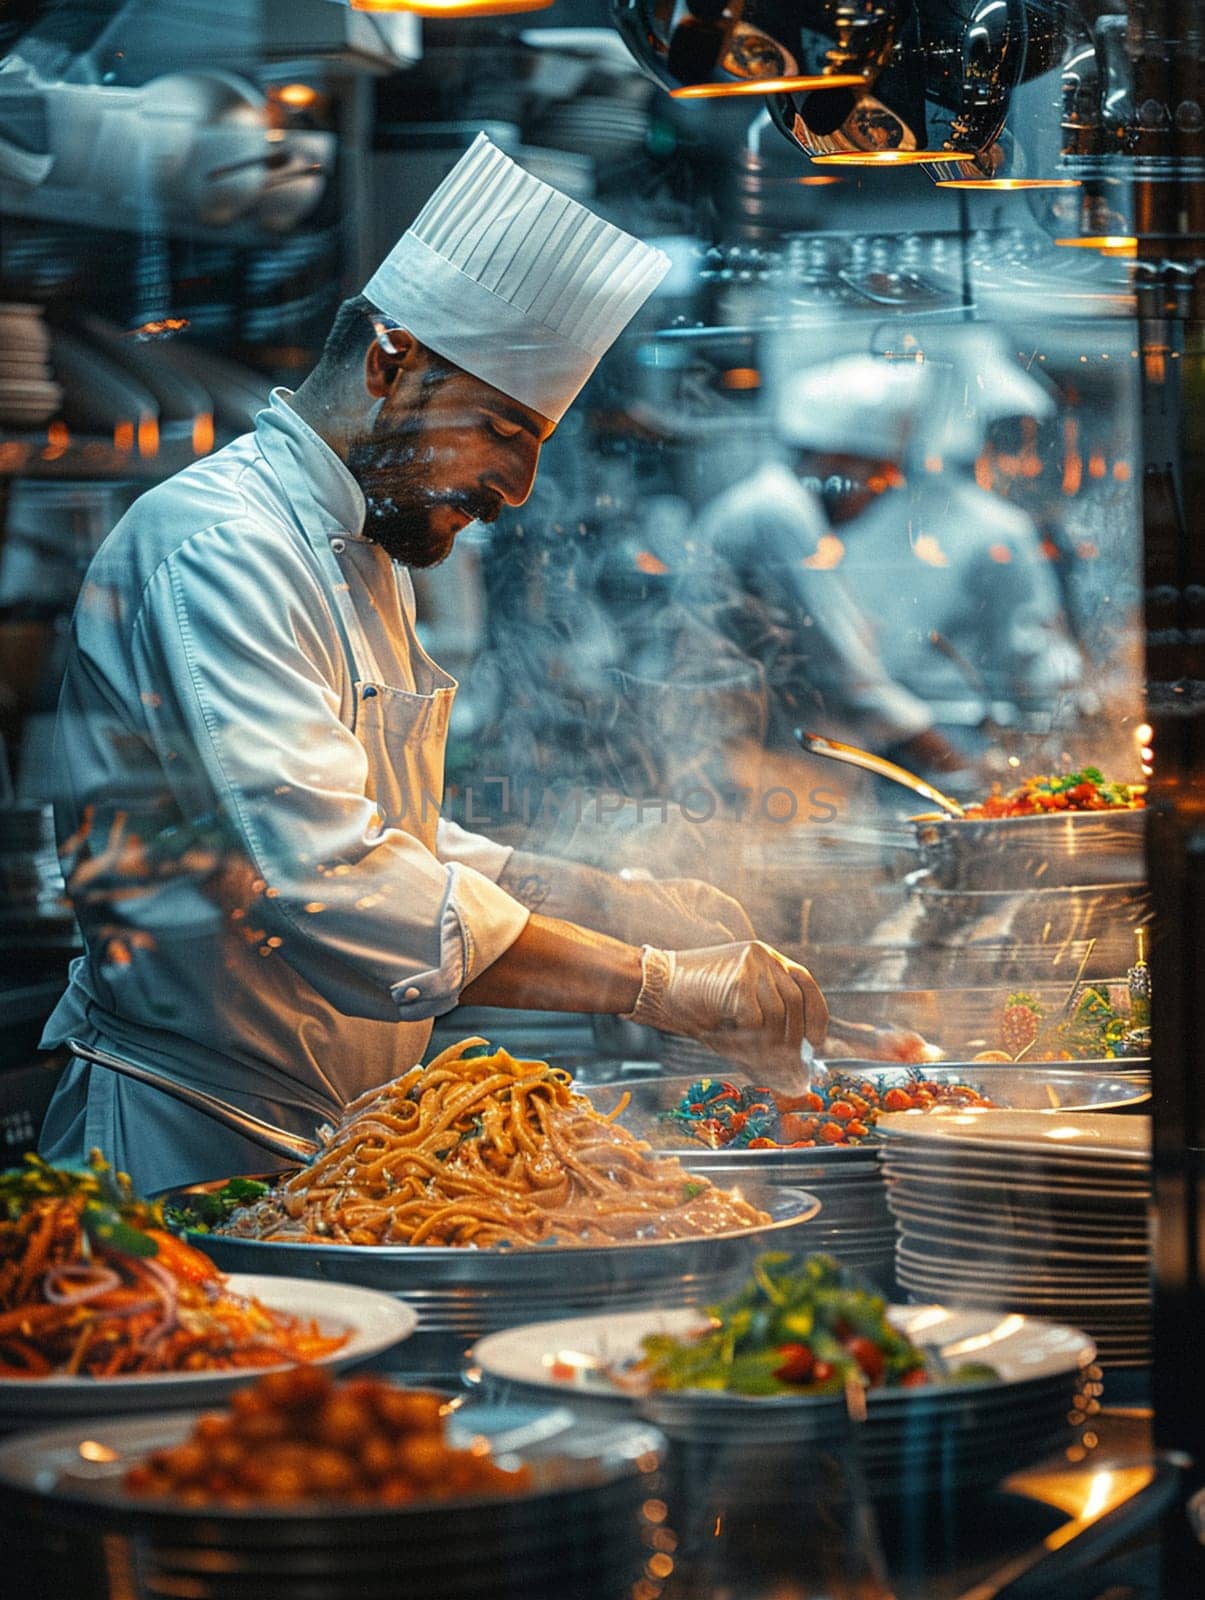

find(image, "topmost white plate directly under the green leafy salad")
[470,1306,1093,1414]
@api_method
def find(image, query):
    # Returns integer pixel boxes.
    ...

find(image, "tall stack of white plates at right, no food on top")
[879,1110,1151,1366]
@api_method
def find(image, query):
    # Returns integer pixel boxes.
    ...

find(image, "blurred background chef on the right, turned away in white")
[809,328,1080,770]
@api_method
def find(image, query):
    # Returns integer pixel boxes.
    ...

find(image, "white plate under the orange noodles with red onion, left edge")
[0,1272,418,1429]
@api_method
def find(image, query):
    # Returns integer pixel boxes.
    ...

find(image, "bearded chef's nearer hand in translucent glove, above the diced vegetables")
[629,939,829,1091]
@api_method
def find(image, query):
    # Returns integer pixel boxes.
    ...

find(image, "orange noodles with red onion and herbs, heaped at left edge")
[0,1152,347,1379]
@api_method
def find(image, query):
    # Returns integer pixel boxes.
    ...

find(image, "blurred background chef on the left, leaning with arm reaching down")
[679,357,963,773]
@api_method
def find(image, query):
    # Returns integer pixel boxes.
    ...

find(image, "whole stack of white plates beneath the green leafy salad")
[472,1306,1099,1499]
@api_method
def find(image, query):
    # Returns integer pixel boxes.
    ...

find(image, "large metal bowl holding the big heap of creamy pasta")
[160,1184,821,1376]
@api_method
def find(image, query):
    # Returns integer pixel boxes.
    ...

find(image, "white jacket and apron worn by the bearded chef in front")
[42,390,528,1190]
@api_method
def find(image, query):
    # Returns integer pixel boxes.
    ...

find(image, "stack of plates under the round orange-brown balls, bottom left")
[0,1405,664,1600]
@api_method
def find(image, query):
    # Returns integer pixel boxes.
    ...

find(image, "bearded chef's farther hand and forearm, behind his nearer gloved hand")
[498,850,754,950]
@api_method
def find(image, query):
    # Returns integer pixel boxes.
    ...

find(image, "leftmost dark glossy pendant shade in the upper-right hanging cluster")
[611,0,898,99]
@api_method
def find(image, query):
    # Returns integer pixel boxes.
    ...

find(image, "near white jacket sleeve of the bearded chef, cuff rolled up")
[130,522,528,1021]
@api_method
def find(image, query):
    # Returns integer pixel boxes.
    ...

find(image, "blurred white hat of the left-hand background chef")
[775,355,928,461]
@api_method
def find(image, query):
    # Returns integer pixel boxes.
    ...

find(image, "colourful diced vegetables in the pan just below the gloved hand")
[664,1074,991,1150]
